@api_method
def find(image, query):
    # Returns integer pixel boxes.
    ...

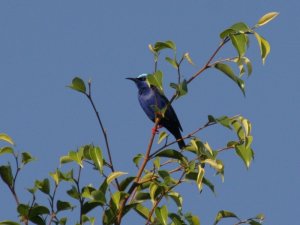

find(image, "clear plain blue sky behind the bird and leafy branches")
[0,0,300,225]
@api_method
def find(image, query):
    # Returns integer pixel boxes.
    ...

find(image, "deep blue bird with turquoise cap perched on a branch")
[126,74,186,149]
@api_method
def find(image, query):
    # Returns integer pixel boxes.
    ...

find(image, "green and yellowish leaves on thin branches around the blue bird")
[0,12,278,225]
